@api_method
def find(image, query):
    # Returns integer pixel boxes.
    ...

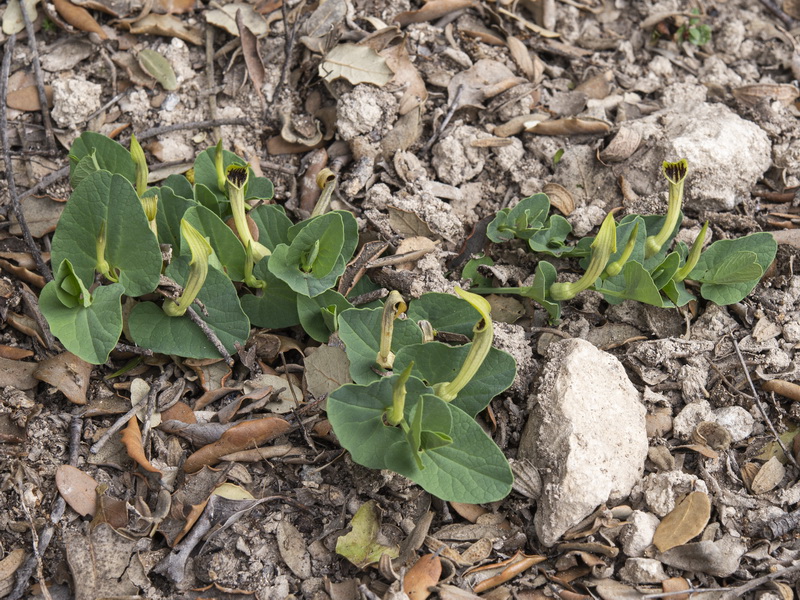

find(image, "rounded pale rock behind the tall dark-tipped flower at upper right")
[622,102,772,210]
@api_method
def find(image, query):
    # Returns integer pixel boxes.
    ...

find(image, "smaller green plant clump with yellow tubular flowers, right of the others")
[464,159,778,322]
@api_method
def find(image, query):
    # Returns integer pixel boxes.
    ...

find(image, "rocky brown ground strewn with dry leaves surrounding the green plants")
[0,0,800,600]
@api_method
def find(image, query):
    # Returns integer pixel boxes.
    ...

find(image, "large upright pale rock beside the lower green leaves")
[518,339,647,546]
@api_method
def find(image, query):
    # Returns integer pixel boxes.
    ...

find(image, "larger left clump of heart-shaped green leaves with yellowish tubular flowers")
[40,133,516,503]
